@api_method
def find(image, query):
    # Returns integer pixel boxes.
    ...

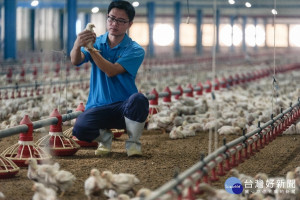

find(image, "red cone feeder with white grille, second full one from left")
[36,109,80,156]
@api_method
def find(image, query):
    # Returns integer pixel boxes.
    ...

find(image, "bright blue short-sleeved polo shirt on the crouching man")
[80,32,145,110]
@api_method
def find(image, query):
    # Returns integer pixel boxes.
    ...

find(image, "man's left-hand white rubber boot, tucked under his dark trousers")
[95,129,112,156]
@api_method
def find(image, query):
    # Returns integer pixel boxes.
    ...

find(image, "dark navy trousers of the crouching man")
[73,93,149,142]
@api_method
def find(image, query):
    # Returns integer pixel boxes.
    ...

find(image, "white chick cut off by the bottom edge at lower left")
[32,183,57,200]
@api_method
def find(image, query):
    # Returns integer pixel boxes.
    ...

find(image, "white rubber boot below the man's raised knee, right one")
[125,117,145,156]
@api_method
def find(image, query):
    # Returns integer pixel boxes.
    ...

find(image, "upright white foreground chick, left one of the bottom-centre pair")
[84,168,107,200]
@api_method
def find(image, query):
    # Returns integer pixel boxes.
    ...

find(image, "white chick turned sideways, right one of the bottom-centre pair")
[101,170,140,195]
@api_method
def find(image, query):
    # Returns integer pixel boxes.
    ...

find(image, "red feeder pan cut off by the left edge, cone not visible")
[0,155,20,179]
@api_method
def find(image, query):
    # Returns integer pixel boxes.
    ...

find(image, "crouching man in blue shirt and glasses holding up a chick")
[70,1,149,156]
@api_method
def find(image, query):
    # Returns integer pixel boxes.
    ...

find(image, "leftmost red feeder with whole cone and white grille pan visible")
[1,115,51,167]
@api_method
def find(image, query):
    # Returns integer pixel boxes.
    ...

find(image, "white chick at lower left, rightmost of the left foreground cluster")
[44,166,76,197]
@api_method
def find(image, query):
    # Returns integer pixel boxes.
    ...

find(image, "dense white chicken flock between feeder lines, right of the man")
[147,75,300,139]
